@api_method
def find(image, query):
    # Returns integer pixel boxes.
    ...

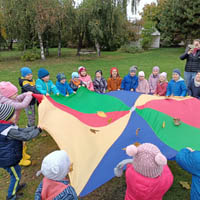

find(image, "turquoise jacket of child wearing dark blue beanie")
[36,79,59,95]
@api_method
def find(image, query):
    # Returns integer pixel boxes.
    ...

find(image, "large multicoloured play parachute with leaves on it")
[34,88,200,196]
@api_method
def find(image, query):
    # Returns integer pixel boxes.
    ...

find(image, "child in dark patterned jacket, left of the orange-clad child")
[93,70,107,93]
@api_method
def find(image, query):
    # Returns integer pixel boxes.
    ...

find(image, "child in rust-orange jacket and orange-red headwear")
[107,67,122,91]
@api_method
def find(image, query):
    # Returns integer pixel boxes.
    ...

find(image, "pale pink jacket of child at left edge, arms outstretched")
[0,93,32,123]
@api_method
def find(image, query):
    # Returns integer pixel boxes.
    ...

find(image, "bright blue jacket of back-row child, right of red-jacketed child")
[166,78,187,97]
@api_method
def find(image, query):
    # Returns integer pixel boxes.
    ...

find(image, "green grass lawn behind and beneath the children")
[0,48,191,200]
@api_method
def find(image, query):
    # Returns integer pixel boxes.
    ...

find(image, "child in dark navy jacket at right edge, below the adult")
[188,72,200,99]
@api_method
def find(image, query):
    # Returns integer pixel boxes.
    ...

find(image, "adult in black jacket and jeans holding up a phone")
[180,39,200,87]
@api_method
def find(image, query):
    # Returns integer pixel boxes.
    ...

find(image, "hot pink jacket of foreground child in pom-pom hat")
[125,164,173,200]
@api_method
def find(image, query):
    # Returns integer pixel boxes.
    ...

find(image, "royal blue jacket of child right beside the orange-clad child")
[121,74,138,91]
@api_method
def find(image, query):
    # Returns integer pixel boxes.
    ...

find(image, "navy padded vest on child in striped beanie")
[0,123,22,167]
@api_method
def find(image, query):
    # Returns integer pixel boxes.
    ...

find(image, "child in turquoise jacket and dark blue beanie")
[36,68,59,96]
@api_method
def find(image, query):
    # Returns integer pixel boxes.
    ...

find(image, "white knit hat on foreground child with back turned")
[36,150,71,181]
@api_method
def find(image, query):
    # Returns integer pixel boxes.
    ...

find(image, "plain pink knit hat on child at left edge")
[0,81,18,98]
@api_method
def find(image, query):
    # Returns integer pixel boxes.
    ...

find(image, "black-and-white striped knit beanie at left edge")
[0,104,15,121]
